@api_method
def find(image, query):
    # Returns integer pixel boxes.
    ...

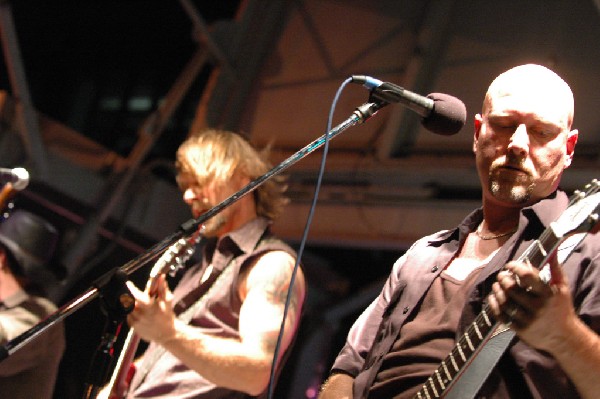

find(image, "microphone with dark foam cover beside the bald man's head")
[351,75,467,136]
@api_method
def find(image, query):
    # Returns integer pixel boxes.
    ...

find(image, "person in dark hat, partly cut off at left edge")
[0,210,65,399]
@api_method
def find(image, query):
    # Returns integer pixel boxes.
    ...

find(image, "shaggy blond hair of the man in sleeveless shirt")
[175,129,289,220]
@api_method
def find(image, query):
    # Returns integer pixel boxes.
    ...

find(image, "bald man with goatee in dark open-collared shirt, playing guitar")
[319,64,600,399]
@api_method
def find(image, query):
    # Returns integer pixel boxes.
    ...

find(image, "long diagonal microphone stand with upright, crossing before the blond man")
[0,98,388,398]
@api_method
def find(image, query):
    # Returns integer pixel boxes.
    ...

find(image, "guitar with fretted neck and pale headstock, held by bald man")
[413,179,600,399]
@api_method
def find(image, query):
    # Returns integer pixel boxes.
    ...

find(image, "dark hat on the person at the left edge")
[0,209,58,278]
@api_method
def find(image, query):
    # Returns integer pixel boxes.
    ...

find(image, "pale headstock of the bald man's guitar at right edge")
[550,179,600,237]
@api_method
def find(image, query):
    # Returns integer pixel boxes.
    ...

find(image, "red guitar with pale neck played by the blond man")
[107,227,203,399]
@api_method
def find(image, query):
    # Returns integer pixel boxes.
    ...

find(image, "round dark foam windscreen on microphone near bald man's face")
[421,93,467,136]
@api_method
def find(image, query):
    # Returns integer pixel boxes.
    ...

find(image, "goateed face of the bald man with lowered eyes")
[473,86,577,206]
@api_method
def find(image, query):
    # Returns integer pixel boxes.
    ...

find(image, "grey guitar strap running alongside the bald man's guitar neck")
[444,234,586,399]
